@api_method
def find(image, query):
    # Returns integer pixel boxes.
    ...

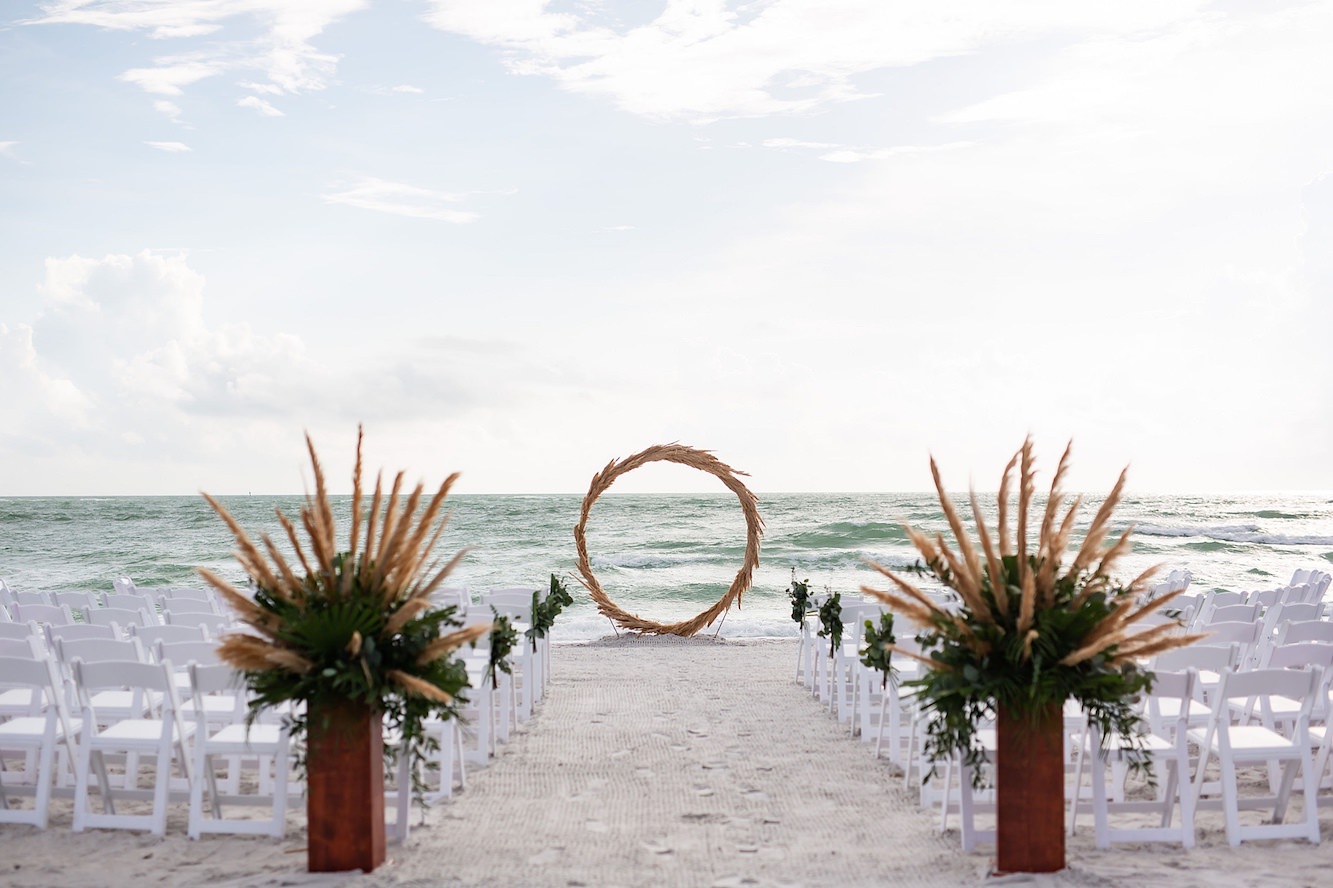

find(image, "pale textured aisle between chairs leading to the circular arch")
[389,636,986,888]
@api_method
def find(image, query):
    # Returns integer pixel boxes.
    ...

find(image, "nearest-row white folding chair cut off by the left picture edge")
[0,657,80,829]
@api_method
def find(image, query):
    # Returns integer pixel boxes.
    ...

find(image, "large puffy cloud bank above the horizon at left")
[0,251,555,493]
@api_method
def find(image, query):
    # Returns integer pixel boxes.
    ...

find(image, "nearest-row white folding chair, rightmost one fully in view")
[1189,669,1320,845]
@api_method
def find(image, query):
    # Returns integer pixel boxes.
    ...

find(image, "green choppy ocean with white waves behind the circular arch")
[0,492,1333,640]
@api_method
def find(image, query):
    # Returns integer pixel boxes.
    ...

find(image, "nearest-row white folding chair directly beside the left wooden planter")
[187,663,292,839]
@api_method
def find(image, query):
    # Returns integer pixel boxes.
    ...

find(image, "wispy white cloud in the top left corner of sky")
[23,0,368,96]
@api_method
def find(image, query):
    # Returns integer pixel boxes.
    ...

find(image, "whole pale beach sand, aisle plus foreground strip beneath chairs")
[0,636,1333,888]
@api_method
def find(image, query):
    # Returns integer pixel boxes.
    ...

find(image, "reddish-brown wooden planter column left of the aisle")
[305,701,385,872]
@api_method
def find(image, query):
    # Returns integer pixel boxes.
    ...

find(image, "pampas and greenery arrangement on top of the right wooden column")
[865,439,1202,780]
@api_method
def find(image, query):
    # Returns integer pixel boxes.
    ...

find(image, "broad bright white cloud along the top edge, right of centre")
[427,0,1205,121]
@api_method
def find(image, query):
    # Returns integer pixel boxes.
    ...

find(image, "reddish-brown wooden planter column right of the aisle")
[996,703,1065,873]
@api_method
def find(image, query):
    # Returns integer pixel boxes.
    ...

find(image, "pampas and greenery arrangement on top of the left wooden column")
[199,429,491,760]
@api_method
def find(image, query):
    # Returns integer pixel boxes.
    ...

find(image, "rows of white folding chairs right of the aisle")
[797,575,1333,849]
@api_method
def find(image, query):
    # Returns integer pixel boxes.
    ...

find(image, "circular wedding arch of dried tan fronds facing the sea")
[575,444,764,637]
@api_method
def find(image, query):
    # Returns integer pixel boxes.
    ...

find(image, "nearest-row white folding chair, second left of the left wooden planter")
[73,660,195,836]
